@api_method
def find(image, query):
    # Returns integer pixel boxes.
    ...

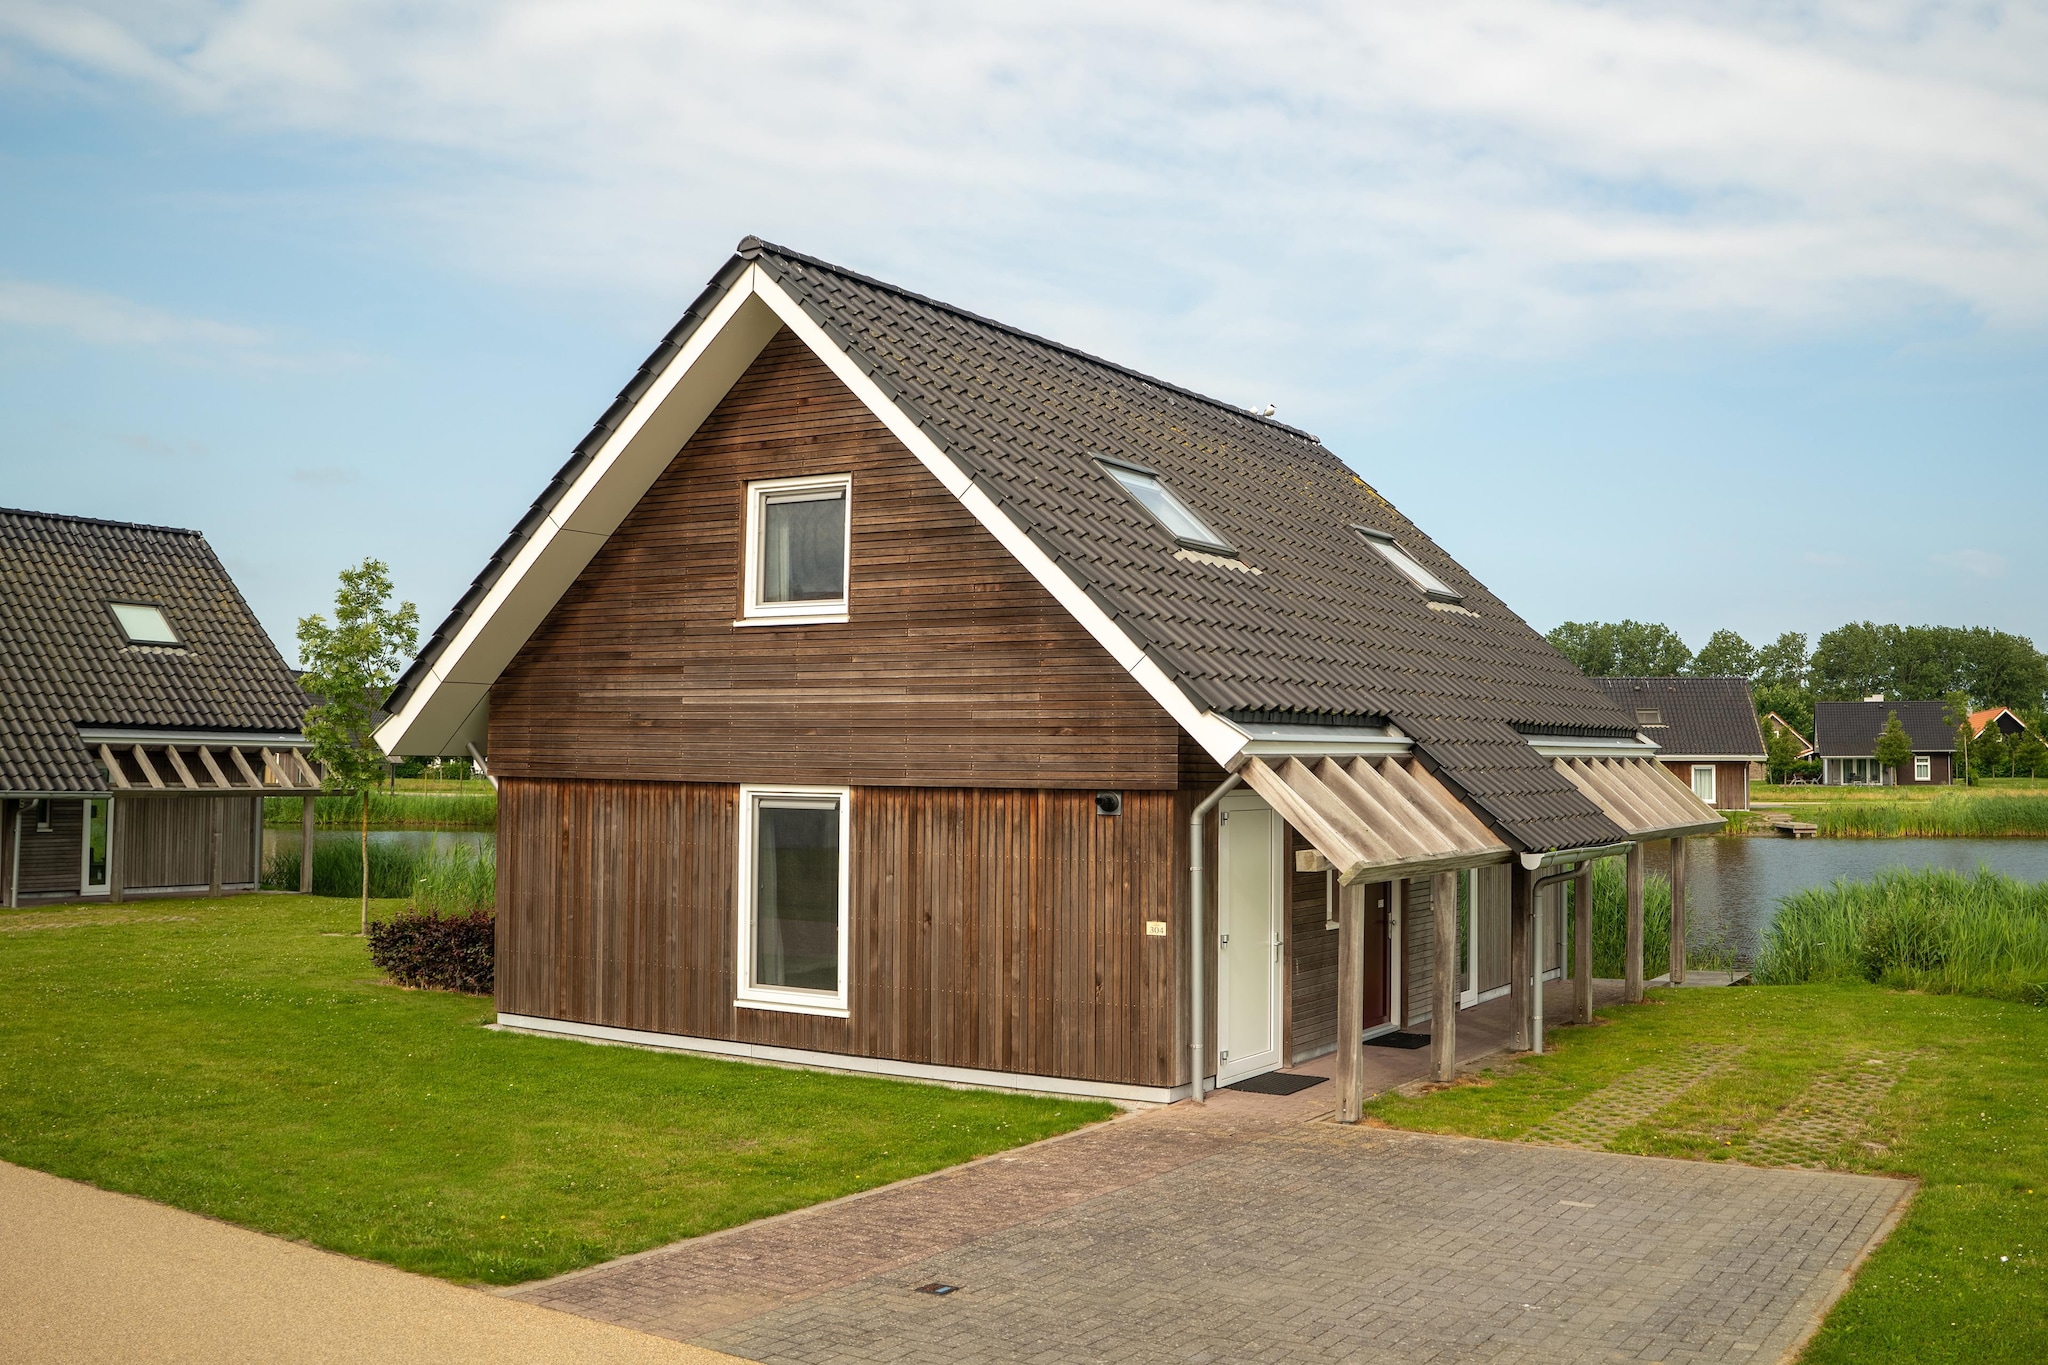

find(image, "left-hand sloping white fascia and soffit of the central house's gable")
[377,268,782,755]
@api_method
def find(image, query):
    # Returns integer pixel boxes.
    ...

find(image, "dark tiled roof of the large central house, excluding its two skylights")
[391,237,1634,847]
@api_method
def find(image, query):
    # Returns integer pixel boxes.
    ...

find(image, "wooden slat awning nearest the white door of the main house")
[1239,757,1507,884]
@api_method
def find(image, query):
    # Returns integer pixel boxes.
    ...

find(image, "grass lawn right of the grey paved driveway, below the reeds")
[1370,984,2048,1365]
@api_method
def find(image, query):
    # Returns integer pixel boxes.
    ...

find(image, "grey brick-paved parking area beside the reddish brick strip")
[700,1121,1911,1365]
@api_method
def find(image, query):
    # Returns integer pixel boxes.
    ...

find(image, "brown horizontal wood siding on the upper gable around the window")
[489,332,1180,790]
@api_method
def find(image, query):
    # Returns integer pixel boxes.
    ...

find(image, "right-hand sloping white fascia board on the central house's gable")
[741,266,1245,767]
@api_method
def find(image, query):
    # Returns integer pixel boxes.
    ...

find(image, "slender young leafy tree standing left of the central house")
[299,559,420,935]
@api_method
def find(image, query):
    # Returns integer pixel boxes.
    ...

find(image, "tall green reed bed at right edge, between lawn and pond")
[1757,868,2048,1005]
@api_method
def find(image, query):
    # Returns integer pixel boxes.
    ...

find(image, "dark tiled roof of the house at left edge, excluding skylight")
[0,510,305,794]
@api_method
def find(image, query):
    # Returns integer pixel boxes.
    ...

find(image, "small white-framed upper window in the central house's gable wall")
[745,475,854,624]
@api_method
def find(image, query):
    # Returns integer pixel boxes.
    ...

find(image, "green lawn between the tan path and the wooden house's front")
[0,896,1112,1283]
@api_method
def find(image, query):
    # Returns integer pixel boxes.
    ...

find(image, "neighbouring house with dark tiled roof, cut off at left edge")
[0,510,319,907]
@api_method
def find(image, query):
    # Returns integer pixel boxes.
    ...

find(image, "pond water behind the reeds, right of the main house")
[1647,837,2048,962]
